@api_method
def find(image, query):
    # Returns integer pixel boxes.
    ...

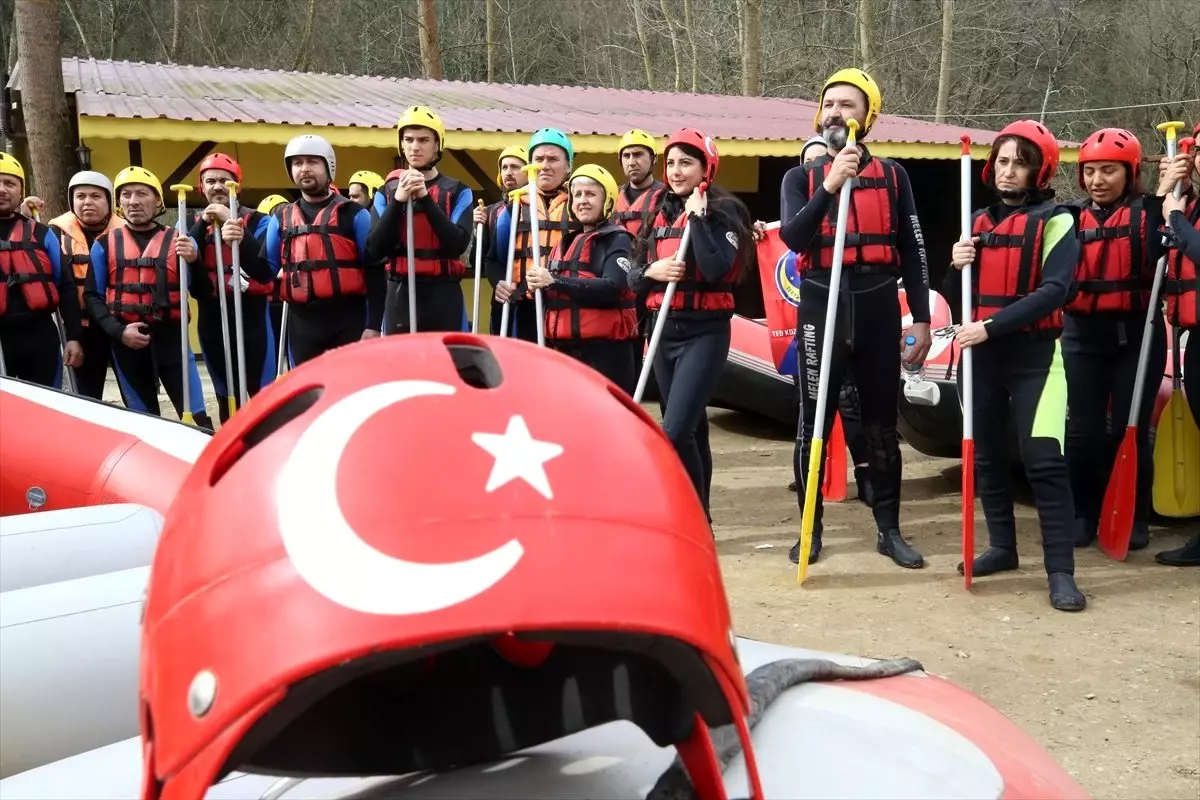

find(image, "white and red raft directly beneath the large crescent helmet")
[0,639,1087,800]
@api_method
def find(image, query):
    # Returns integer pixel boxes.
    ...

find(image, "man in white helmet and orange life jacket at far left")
[25,169,125,399]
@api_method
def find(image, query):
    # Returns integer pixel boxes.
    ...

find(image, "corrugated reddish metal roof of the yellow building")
[10,59,996,144]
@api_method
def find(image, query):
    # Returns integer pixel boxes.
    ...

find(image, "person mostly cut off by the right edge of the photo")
[1154,122,1200,566]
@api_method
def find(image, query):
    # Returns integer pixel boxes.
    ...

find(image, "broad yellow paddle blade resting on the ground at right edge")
[1152,391,1200,518]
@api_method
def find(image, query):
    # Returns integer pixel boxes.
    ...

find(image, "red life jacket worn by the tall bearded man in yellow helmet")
[808,157,900,275]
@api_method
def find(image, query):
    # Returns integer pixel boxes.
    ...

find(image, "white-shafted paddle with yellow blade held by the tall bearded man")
[796,120,858,584]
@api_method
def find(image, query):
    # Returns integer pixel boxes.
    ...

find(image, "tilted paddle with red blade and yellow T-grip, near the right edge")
[1097,121,1183,561]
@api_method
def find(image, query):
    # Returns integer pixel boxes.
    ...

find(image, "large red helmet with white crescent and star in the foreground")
[139,333,762,800]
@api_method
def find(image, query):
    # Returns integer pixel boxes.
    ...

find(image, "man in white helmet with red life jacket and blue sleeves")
[263,133,386,366]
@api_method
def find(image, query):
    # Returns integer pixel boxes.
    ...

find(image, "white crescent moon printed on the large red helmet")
[275,380,524,615]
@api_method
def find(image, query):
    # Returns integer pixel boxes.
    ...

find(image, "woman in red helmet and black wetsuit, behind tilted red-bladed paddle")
[1062,128,1166,551]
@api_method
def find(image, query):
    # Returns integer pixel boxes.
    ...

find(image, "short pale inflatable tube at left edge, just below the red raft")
[0,503,163,593]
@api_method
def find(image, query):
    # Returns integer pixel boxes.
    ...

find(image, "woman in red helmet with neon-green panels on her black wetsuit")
[952,120,1087,610]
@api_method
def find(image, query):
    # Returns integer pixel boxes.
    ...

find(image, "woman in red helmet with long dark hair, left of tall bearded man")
[629,128,756,521]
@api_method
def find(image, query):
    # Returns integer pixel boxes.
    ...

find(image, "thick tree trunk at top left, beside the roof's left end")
[16,0,74,218]
